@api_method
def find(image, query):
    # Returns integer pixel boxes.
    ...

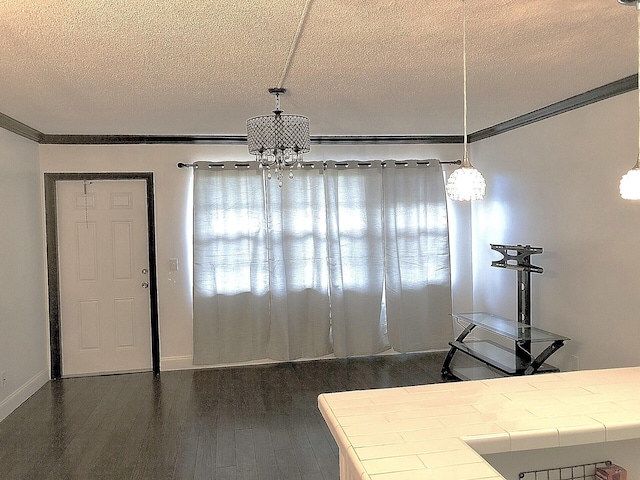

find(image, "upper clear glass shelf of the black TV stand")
[452,312,569,342]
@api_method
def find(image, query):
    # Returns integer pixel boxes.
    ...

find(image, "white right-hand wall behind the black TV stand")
[472,92,640,370]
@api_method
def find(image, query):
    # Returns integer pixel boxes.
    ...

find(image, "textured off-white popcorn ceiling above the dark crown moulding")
[0,0,637,135]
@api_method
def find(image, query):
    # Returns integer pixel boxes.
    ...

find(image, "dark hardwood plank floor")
[0,353,444,480]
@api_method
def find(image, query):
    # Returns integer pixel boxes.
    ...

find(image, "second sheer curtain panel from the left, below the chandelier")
[265,169,331,360]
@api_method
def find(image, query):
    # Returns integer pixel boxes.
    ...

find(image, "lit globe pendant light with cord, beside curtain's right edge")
[446,0,486,201]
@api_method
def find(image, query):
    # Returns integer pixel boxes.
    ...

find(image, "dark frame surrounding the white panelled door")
[44,172,160,379]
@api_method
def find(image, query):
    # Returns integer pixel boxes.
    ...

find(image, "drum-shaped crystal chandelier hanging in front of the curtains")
[247,88,311,186]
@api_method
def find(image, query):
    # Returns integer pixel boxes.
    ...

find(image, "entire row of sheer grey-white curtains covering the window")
[194,161,452,364]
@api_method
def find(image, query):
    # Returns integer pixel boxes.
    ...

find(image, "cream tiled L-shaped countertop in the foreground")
[318,367,640,480]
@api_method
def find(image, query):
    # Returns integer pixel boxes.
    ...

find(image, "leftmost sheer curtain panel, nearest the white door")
[193,167,271,364]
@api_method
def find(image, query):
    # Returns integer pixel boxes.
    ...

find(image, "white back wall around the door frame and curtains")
[40,145,471,370]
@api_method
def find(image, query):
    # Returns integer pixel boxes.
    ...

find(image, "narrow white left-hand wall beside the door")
[0,129,49,420]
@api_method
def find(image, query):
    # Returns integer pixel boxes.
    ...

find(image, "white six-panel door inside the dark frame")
[56,180,152,376]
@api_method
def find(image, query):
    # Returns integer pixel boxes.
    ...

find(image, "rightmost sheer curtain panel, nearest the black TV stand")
[383,161,453,352]
